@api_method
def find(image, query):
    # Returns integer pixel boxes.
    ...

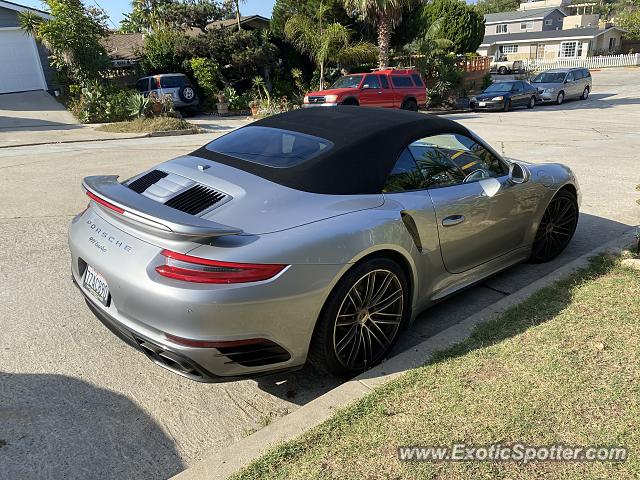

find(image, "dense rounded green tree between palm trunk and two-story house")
[421,0,484,54]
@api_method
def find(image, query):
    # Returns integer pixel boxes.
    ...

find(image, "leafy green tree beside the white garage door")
[18,0,108,83]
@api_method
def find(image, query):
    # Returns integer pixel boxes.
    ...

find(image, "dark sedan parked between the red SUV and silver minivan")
[469,80,538,112]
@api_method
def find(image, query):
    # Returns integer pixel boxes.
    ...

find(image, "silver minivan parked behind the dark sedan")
[531,68,593,105]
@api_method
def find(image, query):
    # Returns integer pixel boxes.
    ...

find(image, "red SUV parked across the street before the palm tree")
[304,69,427,110]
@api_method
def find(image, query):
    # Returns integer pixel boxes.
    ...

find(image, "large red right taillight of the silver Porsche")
[156,250,287,283]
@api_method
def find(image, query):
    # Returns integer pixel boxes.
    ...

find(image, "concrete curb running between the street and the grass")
[172,227,636,480]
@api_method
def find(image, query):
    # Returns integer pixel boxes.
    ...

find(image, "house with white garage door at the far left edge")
[0,0,56,94]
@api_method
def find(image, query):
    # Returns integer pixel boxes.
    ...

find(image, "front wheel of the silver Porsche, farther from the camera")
[530,190,580,263]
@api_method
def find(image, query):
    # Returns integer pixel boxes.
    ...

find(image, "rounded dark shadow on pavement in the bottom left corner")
[0,372,185,480]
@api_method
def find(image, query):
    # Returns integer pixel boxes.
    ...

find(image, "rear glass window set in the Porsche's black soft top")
[207,125,333,168]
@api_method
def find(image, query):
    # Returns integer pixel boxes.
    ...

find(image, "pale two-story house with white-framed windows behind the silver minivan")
[478,5,624,61]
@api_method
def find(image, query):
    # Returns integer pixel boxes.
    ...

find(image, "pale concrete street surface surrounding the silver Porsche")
[0,69,640,479]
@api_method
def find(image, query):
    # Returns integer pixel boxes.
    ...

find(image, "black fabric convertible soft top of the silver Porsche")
[192,106,470,195]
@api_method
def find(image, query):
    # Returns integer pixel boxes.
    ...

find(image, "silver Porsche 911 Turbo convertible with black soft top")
[69,107,580,381]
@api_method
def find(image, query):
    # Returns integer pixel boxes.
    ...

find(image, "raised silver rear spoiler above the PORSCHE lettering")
[82,175,243,240]
